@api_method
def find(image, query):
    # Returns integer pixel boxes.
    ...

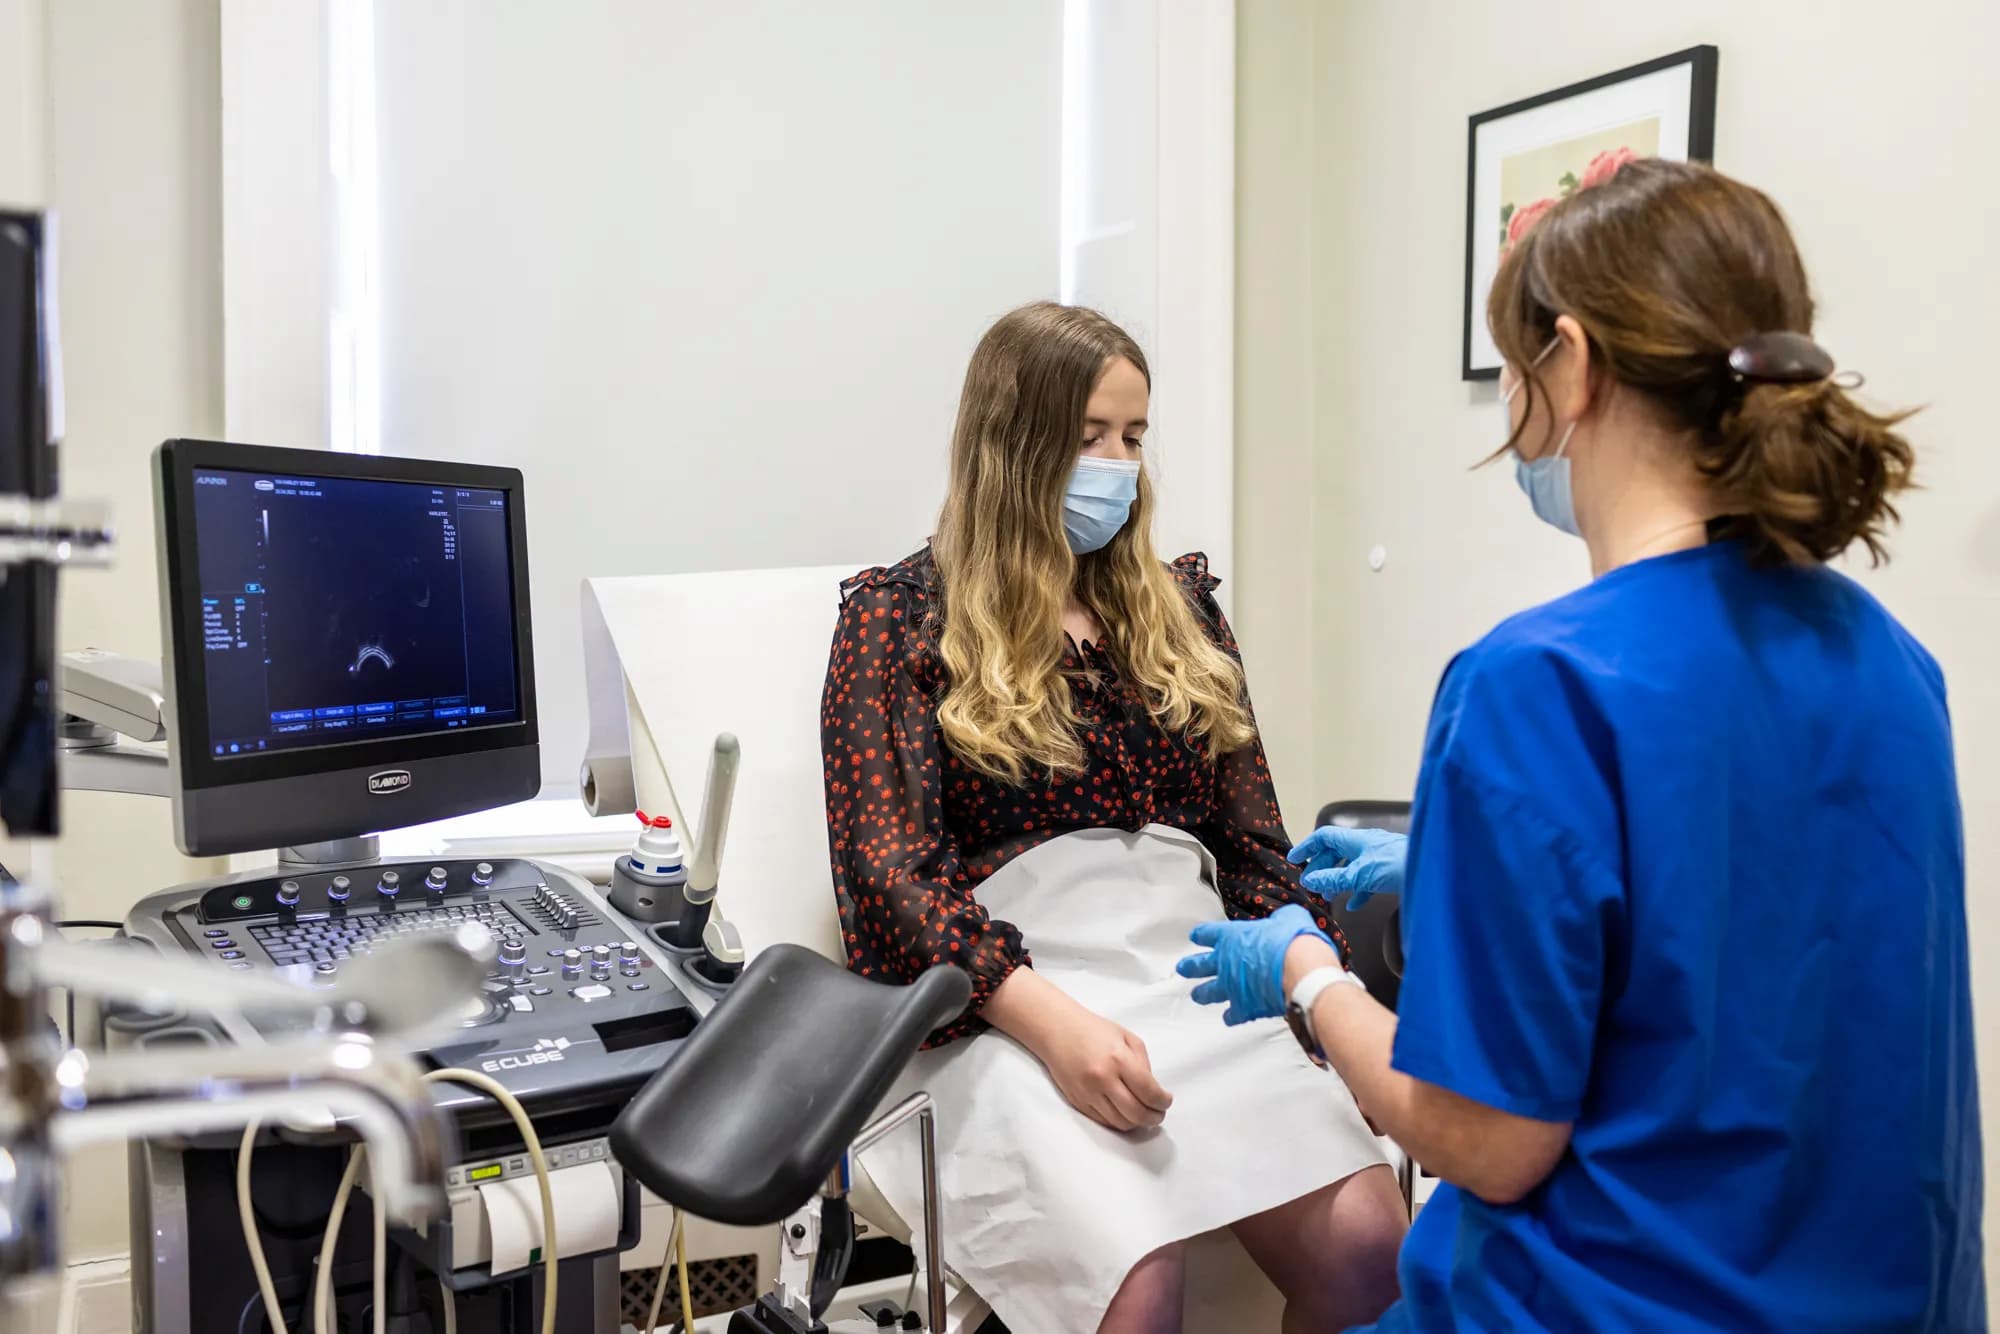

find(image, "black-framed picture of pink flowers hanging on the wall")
[1462,46,1718,380]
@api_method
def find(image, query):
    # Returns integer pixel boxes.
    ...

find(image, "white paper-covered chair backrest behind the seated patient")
[592,564,876,962]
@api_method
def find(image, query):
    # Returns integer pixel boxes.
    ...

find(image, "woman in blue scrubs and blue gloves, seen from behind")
[1182,160,1986,1332]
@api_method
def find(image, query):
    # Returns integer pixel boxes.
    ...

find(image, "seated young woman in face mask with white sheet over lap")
[822,304,1404,1334]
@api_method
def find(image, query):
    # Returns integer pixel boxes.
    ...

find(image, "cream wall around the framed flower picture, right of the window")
[1238,0,2000,1304]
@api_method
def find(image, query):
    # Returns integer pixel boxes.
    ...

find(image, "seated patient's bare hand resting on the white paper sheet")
[984,968,1174,1130]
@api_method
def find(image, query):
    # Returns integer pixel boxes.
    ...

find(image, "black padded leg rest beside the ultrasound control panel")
[610,944,972,1228]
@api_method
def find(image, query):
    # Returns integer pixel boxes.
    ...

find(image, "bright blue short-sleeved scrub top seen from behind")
[1376,542,1986,1332]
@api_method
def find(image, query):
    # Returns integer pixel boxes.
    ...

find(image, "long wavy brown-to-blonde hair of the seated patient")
[932,302,1254,784]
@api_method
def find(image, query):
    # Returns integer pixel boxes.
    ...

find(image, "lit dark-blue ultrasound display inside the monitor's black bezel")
[194,470,520,758]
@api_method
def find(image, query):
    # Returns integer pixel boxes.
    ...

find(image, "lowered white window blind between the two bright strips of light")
[374,0,1060,786]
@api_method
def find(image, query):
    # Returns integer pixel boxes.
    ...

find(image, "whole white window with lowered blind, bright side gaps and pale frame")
[211,0,1234,794]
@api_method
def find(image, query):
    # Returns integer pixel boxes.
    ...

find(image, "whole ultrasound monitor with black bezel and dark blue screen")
[154,440,540,856]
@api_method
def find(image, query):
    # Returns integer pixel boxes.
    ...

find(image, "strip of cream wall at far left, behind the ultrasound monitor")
[0,0,222,1260]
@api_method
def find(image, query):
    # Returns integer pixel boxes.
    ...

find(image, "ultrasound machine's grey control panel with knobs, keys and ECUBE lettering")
[126,858,696,1104]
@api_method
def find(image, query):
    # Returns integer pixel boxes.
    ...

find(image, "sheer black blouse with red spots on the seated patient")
[820,548,1344,1044]
